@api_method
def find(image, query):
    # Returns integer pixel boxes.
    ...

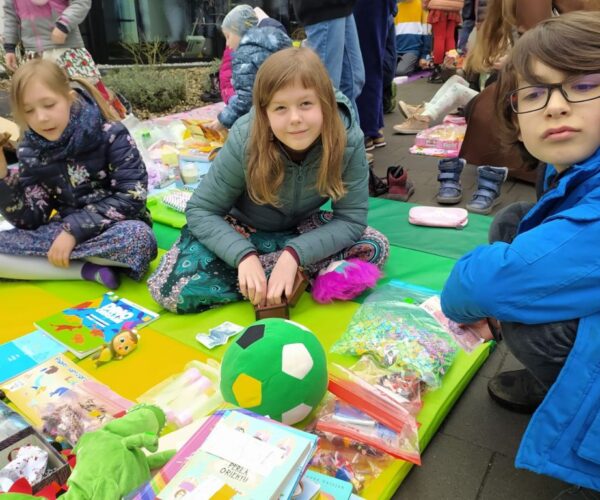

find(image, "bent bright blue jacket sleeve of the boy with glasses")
[441,211,600,324]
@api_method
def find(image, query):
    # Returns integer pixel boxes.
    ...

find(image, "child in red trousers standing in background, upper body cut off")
[423,0,463,83]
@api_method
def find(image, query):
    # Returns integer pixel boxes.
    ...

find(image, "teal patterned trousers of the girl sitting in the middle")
[148,212,389,314]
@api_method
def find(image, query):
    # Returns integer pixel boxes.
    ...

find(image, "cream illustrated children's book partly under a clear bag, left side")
[2,354,132,432]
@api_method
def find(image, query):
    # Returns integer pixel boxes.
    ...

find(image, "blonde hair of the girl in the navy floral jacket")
[10,59,118,129]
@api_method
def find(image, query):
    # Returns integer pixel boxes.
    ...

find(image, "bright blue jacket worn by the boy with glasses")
[442,149,600,490]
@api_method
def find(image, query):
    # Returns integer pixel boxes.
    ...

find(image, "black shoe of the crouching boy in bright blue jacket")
[488,369,547,414]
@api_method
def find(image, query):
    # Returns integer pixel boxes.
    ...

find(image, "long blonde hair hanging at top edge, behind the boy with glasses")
[465,0,516,74]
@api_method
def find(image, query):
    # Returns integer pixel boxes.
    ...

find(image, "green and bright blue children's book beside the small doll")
[35,292,159,359]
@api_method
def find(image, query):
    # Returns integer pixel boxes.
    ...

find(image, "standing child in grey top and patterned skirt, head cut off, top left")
[3,0,126,118]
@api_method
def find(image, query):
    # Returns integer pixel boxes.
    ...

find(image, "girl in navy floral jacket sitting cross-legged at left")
[0,59,157,289]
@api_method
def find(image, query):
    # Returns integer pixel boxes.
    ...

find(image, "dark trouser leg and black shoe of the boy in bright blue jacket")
[488,202,579,412]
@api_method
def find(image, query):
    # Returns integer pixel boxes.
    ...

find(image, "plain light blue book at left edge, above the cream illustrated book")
[0,330,66,383]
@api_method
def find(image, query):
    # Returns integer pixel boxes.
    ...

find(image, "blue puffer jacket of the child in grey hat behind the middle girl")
[218,26,292,128]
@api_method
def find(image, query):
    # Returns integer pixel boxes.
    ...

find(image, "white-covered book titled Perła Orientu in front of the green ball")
[152,410,317,500]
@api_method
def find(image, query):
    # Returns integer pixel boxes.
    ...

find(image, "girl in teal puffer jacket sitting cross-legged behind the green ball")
[148,48,389,313]
